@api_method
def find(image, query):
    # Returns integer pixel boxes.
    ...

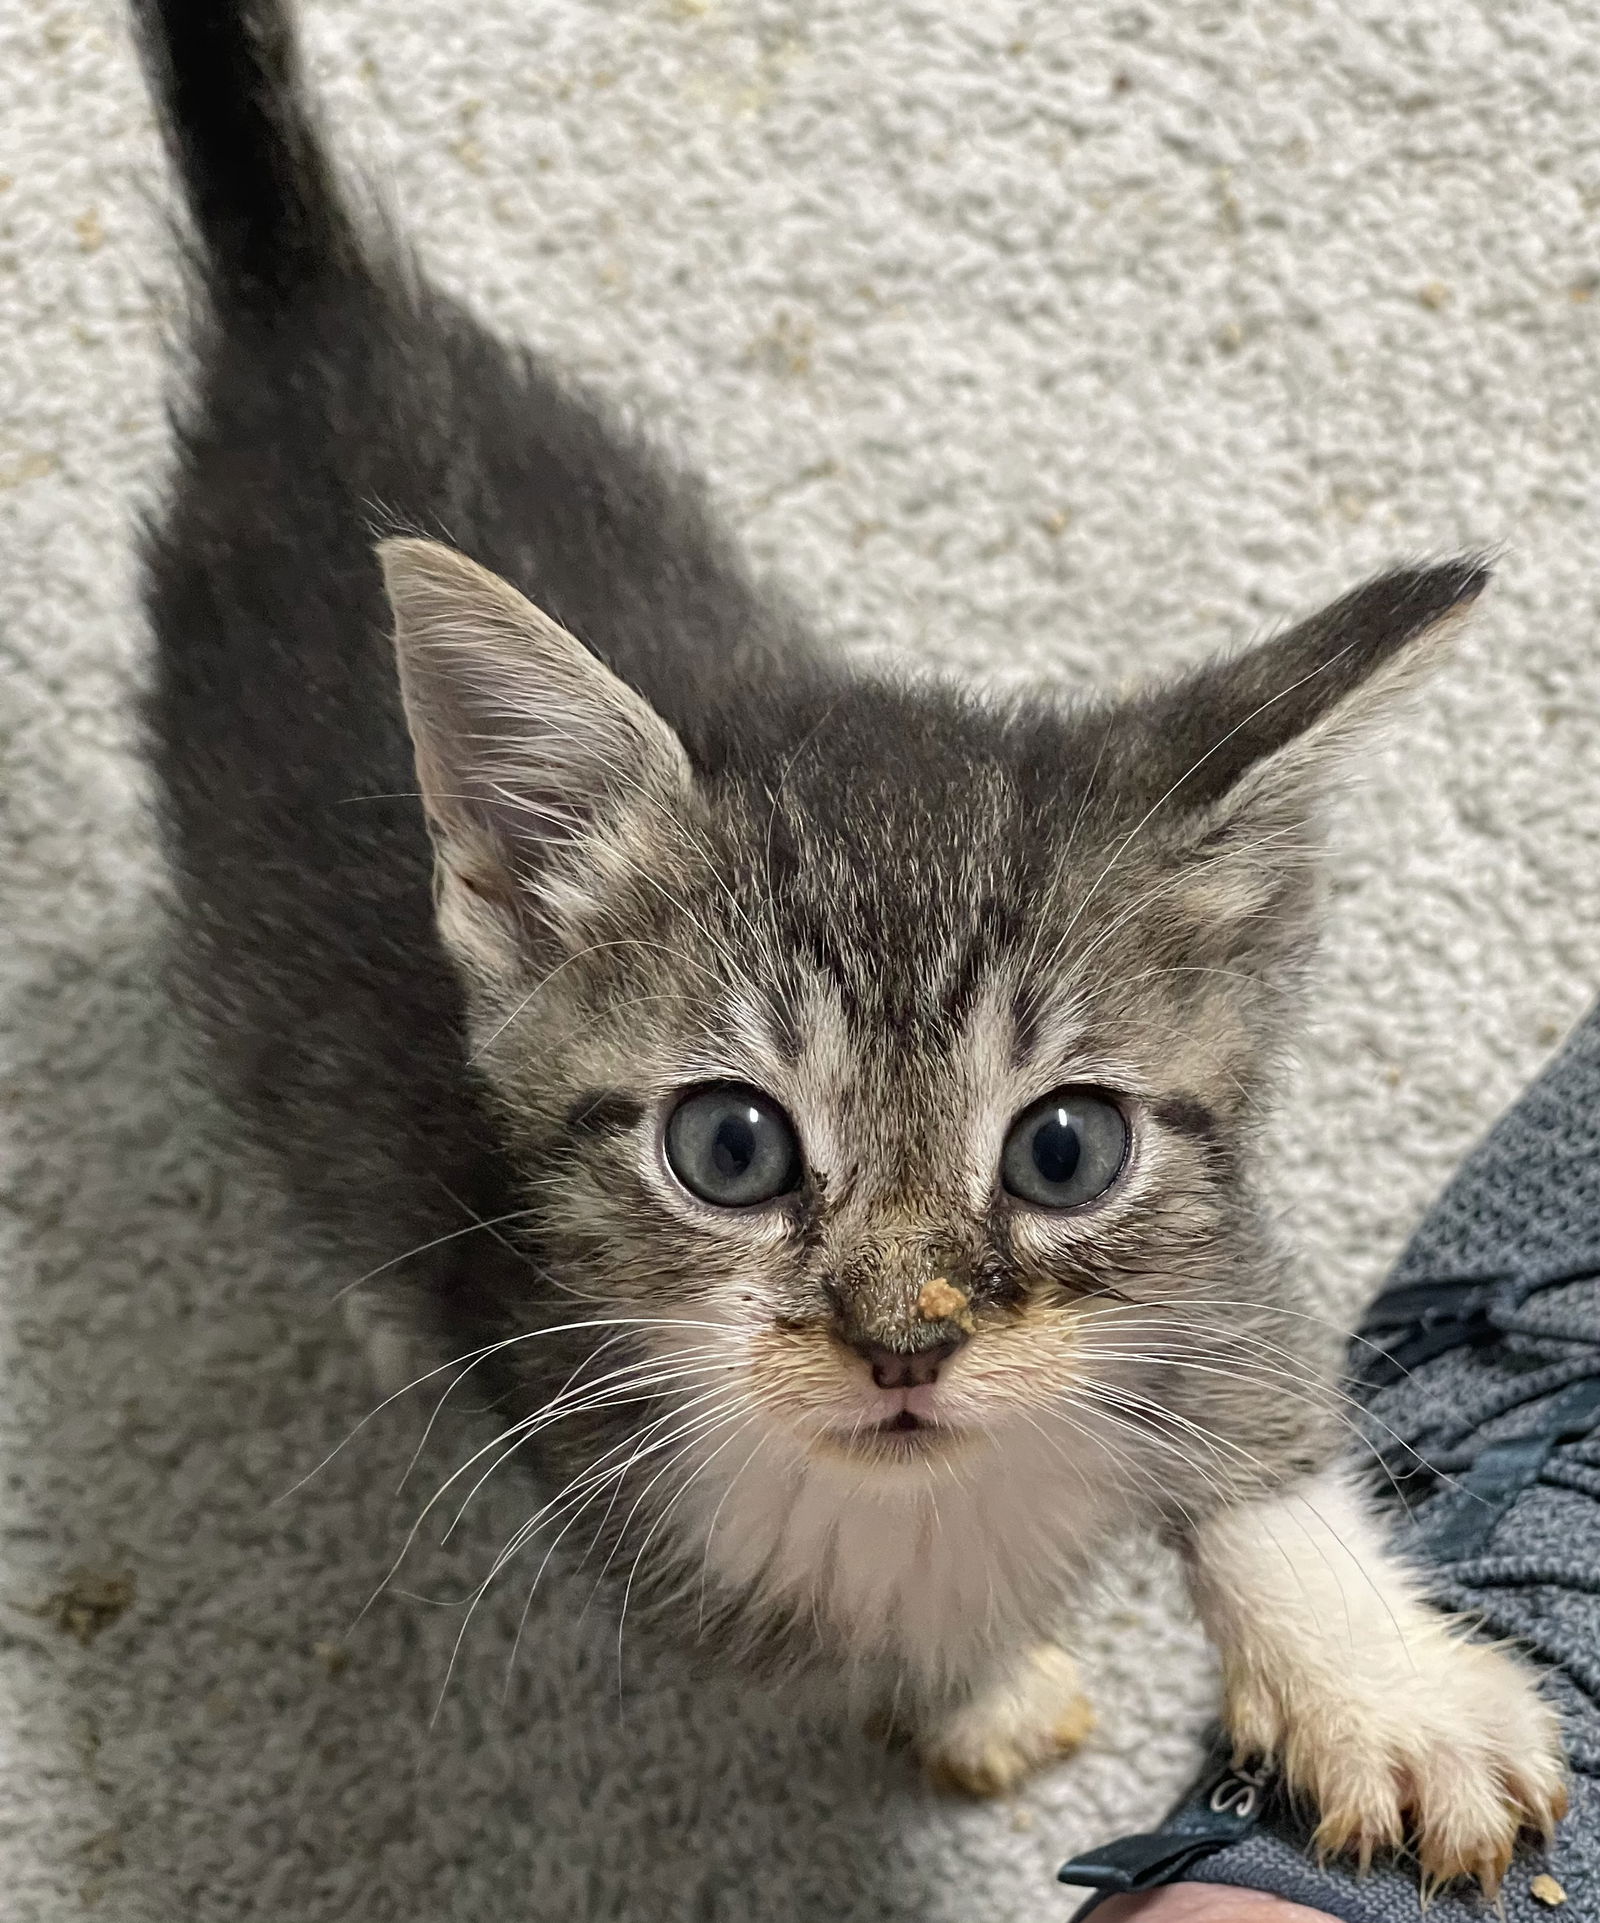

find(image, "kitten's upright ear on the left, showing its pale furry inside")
[377,538,690,975]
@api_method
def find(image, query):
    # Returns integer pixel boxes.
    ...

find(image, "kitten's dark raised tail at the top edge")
[133,0,362,306]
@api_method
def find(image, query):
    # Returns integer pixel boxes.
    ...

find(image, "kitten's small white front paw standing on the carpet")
[919,1644,1094,1796]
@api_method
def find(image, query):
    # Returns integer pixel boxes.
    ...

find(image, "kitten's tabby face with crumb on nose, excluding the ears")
[475,694,1300,1488]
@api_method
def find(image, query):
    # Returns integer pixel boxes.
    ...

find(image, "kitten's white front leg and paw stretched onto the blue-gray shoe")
[1188,1473,1567,1894]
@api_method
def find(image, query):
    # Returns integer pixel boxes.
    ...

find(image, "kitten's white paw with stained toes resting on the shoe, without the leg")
[1225,1619,1567,1896]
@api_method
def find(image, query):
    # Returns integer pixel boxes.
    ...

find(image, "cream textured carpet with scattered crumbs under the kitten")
[0,0,1600,1923]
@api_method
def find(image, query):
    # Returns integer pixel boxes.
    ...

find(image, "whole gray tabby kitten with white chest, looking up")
[138,0,1563,1888]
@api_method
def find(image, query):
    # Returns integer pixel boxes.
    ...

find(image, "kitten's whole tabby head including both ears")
[383,540,1487,1523]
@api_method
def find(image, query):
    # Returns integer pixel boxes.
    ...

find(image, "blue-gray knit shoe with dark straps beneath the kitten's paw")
[1084,1008,1600,1923]
